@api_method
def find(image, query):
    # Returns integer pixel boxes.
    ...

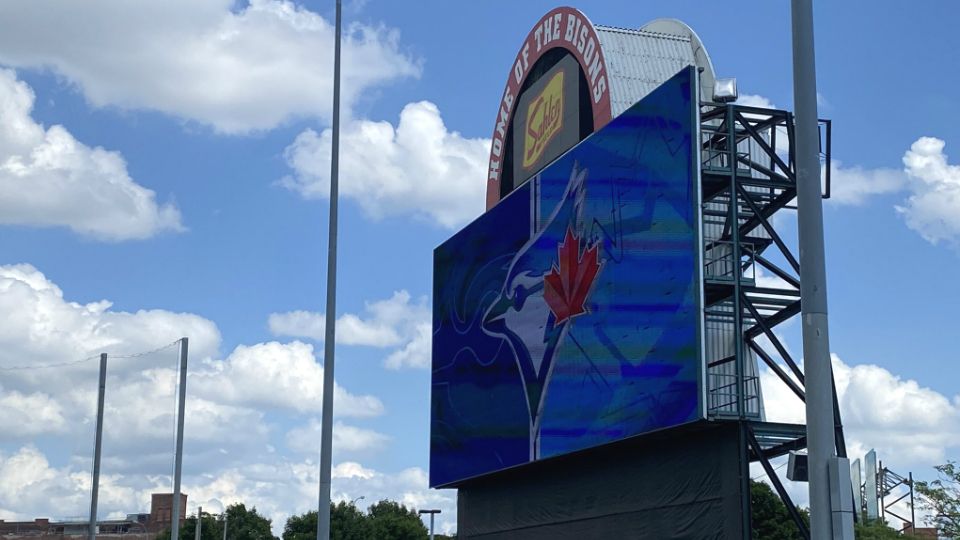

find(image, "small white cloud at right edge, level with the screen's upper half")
[897,137,960,246]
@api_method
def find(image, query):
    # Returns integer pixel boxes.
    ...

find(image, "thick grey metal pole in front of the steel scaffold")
[791,0,836,540]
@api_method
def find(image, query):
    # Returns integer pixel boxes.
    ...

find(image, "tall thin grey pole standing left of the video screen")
[317,0,340,540]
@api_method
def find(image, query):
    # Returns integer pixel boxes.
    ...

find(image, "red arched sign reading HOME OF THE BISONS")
[487,7,611,209]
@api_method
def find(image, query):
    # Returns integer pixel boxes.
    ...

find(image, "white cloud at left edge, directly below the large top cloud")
[0,68,183,241]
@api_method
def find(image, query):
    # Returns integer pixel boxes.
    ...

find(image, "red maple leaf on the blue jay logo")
[543,227,600,324]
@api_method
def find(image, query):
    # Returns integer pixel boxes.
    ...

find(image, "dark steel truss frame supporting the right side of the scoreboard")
[700,103,846,539]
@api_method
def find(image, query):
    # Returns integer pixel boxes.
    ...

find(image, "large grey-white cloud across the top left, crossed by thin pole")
[0,0,420,133]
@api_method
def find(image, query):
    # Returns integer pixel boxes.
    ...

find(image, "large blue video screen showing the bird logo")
[430,68,703,487]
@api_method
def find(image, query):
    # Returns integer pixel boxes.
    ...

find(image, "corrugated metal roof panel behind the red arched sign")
[596,26,696,117]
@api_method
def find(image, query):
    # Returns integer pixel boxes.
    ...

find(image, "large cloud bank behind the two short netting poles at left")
[0,265,383,478]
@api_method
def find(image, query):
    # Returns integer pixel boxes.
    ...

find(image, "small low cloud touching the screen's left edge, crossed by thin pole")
[268,290,432,369]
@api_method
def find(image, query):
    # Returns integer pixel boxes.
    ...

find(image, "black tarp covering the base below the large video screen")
[457,423,746,540]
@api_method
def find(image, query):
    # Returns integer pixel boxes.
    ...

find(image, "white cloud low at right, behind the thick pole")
[761,355,960,473]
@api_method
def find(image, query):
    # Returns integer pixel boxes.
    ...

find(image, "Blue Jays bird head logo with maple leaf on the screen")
[483,163,600,460]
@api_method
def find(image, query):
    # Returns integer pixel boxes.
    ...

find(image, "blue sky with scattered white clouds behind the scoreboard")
[0,0,960,532]
